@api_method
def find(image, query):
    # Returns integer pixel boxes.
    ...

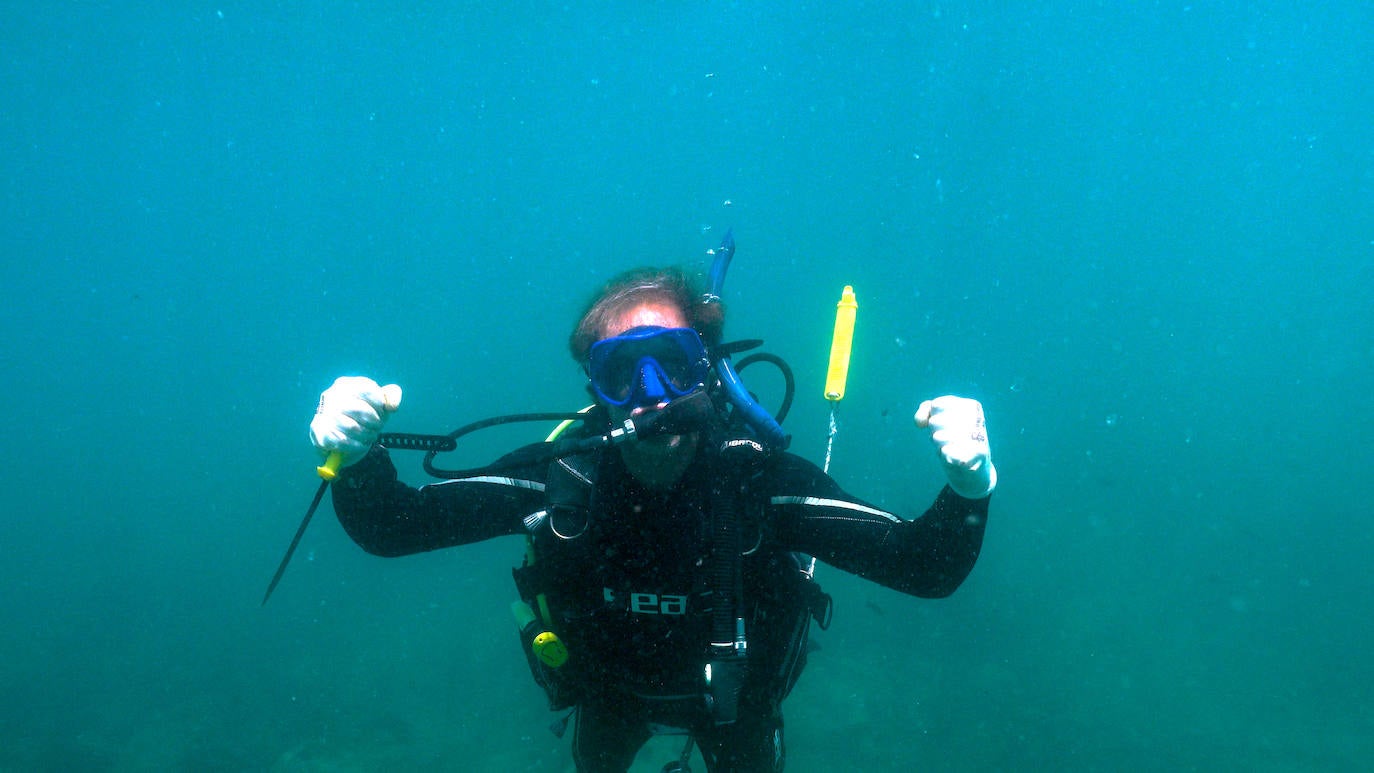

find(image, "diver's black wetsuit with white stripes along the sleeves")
[333,433,988,773]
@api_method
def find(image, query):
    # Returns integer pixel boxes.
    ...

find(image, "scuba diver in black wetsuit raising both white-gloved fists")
[303,252,996,773]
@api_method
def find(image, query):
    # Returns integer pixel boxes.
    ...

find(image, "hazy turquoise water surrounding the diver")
[0,0,1374,772]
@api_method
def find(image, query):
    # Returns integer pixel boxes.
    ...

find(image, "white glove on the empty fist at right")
[916,394,998,500]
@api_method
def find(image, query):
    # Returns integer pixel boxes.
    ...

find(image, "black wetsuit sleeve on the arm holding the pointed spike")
[330,446,544,556]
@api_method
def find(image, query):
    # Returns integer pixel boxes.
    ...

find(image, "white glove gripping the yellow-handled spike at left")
[311,376,401,467]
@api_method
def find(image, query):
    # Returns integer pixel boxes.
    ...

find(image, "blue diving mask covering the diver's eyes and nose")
[587,325,710,408]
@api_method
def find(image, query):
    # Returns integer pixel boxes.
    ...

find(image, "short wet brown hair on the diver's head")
[567,266,725,362]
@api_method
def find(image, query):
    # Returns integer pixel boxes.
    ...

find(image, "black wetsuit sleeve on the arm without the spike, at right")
[765,454,989,599]
